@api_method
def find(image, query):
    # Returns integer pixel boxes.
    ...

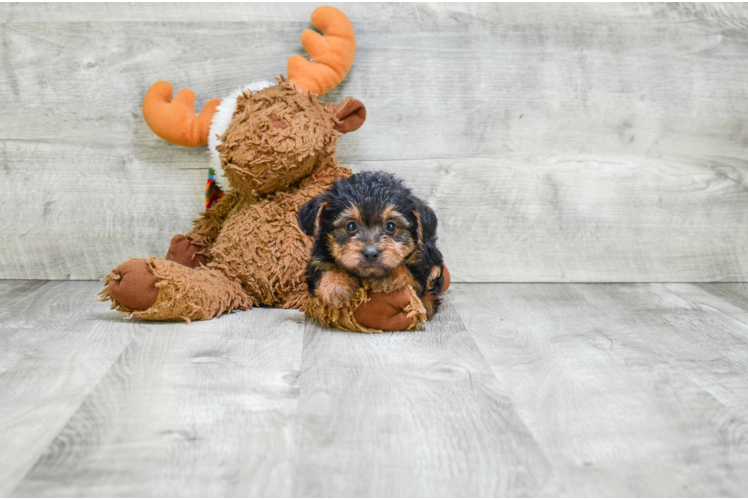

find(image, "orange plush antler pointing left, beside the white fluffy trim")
[143,80,221,147]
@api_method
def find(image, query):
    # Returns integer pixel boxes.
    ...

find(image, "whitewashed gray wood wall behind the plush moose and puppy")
[0,3,748,281]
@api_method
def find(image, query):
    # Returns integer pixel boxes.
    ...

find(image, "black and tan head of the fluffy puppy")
[298,172,437,278]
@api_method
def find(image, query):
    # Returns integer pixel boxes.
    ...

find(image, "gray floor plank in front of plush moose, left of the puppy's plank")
[14,309,304,498]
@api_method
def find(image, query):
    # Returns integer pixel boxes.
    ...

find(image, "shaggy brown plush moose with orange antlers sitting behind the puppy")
[101,7,448,332]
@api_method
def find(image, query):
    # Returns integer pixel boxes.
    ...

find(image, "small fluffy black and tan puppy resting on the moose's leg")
[298,172,444,319]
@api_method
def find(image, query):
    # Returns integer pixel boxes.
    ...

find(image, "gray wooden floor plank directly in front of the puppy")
[294,304,549,498]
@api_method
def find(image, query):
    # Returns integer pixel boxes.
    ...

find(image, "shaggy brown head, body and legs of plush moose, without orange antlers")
[101,79,438,332]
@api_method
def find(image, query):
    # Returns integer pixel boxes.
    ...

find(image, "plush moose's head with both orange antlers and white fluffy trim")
[143,7,366,195]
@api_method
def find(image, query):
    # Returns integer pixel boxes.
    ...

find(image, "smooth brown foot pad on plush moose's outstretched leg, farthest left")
[108,259,158,311]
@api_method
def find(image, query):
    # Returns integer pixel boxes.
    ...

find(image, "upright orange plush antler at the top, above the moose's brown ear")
[286,7,356,95]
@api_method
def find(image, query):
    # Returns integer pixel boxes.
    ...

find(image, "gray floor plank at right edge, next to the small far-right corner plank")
[582,283,748,414]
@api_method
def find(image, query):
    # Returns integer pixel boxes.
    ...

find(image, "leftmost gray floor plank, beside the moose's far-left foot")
[0,281,133,498]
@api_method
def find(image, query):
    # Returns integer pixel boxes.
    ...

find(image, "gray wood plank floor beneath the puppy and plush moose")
[0,281,748,498]
